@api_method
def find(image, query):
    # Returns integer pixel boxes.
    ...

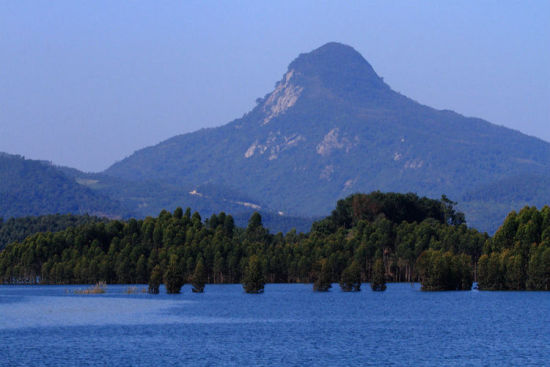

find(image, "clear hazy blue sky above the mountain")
[0,0,550,171]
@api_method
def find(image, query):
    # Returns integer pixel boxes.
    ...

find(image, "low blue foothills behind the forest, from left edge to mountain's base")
[0,153,314,236]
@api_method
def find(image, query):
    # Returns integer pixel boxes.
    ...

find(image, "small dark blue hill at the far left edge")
[0,153,123,218]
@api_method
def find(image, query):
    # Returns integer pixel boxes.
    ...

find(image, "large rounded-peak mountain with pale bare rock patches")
[104,43,550,231]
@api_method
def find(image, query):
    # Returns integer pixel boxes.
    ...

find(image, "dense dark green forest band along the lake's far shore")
[0,192,550,291]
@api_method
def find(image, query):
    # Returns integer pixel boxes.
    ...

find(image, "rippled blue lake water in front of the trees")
[0,284,550,366]
